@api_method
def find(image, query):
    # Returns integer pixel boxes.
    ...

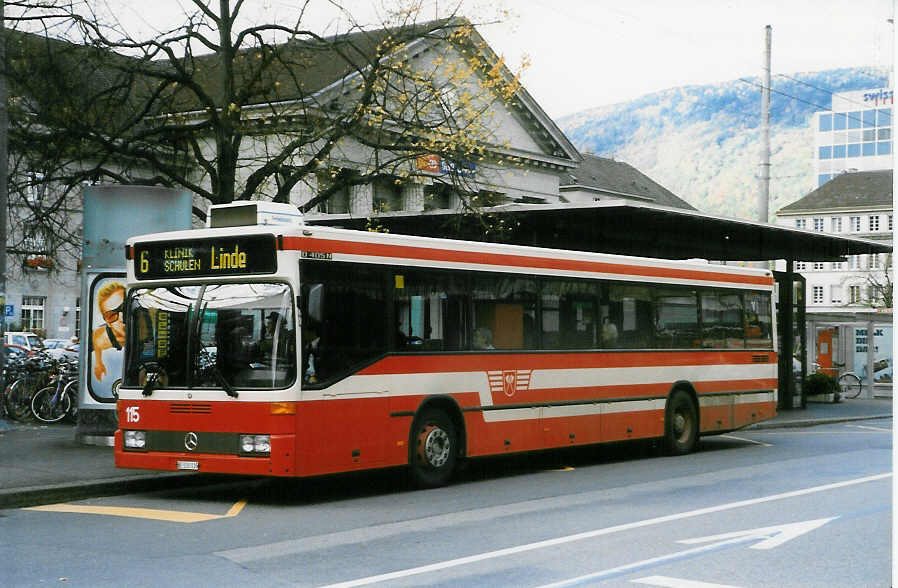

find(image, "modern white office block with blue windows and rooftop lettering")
[811,88,894,186]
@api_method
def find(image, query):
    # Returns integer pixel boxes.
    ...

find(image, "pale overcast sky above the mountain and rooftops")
[103,0,894,118]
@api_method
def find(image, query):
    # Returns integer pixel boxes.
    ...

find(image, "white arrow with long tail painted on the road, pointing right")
[540,517,838,588]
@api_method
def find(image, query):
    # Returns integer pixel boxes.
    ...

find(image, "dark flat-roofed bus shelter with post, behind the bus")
[306,200,892,409]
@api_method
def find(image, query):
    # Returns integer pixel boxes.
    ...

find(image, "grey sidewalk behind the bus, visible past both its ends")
[0,398,892,509]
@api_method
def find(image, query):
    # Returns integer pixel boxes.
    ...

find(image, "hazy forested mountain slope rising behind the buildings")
[557,68,888,220]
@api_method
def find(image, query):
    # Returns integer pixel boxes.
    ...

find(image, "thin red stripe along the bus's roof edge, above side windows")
[284,237,773,286]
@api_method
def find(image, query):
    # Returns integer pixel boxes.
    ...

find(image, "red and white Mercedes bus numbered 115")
[115,204,777,486]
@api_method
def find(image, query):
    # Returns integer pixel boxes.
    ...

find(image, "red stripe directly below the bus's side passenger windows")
[357,351,776,376]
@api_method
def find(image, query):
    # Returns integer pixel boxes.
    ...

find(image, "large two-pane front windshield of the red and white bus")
[124,283,296,394]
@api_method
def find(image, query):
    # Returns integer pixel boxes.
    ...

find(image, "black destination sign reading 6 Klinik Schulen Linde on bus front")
[134,235,277,280]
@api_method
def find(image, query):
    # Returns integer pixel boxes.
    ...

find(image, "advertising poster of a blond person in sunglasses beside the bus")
[87,275,125,400]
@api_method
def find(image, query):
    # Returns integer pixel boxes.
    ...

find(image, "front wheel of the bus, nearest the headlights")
[409,408,458,488]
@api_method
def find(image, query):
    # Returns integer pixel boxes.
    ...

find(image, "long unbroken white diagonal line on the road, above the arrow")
[318,472,892,588]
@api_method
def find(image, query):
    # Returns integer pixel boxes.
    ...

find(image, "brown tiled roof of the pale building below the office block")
[779,170,892,213]
